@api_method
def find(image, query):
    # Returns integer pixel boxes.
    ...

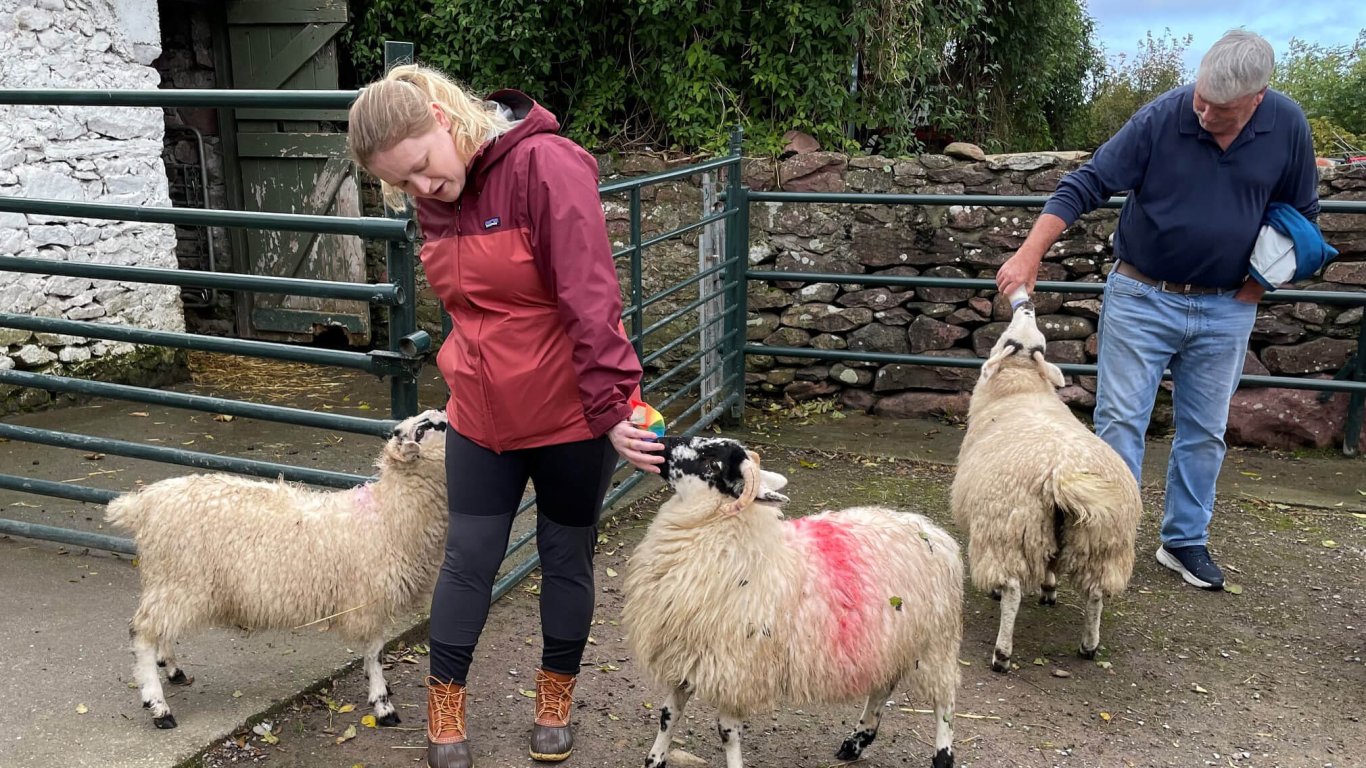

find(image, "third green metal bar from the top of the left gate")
[0,256,406,305]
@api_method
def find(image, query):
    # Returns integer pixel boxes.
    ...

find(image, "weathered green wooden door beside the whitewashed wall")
[227,0,370,344]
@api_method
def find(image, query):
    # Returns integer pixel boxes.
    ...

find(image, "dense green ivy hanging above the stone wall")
[347,0,1096,153]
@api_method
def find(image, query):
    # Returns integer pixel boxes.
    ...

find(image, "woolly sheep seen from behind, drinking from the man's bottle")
[951,302,1143,672]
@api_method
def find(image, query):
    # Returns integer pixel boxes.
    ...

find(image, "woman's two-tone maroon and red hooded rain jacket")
[417,90,641,452]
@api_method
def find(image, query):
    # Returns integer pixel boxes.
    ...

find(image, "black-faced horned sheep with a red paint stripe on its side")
[622,437,963,768]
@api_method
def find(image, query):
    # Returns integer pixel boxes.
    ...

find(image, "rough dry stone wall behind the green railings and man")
[587,146,1366,447]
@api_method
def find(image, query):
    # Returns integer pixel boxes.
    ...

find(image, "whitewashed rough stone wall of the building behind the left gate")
[0,0,184,377]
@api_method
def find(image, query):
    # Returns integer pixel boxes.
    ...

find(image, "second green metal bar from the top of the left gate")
[0,195,418,241]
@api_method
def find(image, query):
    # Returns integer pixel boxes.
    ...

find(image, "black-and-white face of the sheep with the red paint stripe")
[660,437,788,504]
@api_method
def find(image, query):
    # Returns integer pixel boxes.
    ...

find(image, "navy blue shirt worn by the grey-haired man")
[1044,85,1318,288]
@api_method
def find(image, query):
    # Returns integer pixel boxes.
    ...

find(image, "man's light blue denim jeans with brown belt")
[1096,266,1257,548]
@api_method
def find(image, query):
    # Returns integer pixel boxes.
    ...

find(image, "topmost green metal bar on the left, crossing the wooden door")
[0,87,361,109]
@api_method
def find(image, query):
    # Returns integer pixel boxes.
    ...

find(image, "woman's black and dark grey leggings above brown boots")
[432,429,616,685]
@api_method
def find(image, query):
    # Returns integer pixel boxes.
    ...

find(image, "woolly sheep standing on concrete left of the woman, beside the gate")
[105,411,448,728]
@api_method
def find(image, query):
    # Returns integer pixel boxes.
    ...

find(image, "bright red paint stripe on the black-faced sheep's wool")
[790,517,880,687]
